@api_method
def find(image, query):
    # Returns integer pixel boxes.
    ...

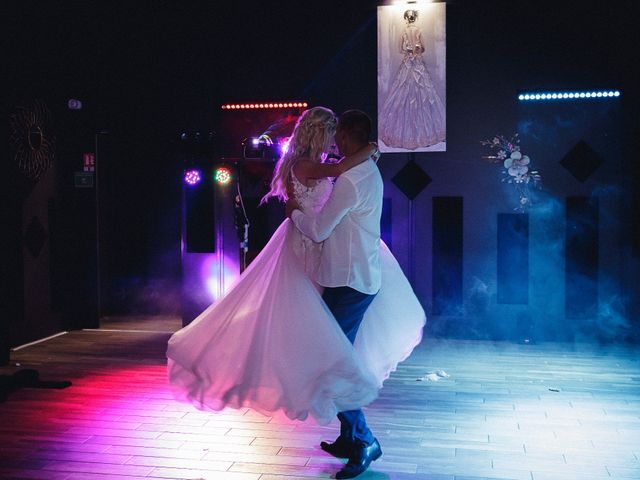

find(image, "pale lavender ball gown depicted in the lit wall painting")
[379,25,446,150]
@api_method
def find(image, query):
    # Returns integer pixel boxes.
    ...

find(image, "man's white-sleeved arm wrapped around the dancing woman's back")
[291,177,358,242]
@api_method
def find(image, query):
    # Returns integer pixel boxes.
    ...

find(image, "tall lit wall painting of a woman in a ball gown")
[378,2,447,152]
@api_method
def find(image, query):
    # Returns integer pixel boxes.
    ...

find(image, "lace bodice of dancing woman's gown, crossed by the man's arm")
[291,172,333,278]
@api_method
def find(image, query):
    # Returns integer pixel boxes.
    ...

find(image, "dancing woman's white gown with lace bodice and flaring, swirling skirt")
[167,172,425,424]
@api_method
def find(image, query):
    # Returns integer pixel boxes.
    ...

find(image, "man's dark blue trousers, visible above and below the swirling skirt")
[322,287,376,445]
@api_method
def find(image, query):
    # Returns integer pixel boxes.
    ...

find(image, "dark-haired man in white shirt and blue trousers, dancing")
[287,110,382,478]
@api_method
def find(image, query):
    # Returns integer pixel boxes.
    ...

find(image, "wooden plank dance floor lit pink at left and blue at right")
[0,319,640,480]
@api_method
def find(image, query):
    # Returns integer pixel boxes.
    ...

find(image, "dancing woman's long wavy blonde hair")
[260,107,338,203]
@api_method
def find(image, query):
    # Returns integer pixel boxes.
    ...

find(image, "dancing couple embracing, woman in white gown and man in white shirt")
[167,107,425,478]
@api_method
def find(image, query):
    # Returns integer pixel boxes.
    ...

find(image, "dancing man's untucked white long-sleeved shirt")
[291,159,383,294]
